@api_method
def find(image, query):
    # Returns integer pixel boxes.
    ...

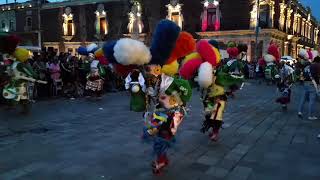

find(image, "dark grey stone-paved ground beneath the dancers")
[0,82,320,180]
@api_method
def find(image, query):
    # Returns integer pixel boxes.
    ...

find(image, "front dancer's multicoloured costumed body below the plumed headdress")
[143,74,192,174]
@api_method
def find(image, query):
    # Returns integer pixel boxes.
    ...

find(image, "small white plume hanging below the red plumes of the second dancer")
[198,62,213,88]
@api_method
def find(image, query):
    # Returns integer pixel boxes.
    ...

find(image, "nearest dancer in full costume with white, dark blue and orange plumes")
[103,20,195,174]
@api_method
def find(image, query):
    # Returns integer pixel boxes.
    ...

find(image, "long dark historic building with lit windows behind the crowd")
[0,0,319,60]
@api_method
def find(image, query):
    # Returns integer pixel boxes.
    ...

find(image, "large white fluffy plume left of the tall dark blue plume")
[113,38,151,65]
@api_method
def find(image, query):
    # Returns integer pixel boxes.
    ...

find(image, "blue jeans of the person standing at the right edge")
[299,82,317,117]
